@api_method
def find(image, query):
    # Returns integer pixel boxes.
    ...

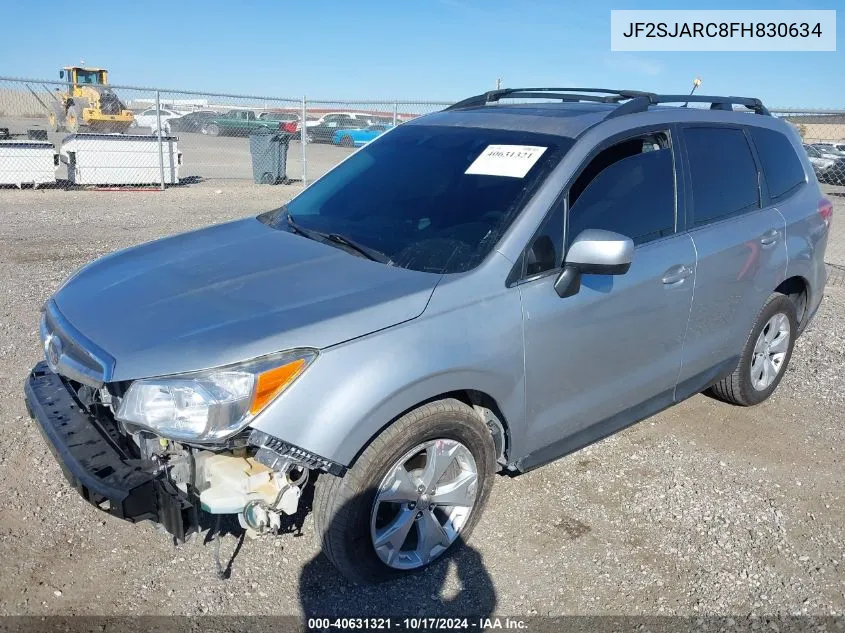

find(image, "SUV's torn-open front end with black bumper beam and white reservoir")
[25,362,344,542]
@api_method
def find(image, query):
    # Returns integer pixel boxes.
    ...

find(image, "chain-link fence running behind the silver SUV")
[0,71,845,270]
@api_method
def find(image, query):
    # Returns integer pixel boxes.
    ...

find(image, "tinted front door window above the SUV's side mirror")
[567,149,675,244]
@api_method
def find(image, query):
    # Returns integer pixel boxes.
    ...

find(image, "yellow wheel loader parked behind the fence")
[47,66,135,133]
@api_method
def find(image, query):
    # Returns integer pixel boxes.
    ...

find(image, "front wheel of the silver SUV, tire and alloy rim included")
[314,398,496,583]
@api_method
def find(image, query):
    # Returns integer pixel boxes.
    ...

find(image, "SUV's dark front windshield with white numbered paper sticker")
[259,125,573,273]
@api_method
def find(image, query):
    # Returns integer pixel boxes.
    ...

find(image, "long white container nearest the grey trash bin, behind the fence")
[61,134,182,185]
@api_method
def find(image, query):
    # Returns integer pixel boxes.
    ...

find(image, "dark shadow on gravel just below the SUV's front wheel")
[299,488,497,626]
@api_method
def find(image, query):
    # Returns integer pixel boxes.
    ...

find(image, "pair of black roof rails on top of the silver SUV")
[446,88,771,119]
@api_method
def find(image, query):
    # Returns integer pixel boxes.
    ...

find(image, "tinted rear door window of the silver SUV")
[684,127,760,226]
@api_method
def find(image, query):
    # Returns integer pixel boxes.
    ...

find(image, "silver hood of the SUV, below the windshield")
[54,218,440,381]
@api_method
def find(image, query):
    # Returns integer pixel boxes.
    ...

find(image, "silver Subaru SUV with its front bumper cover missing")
[26,88,832,581]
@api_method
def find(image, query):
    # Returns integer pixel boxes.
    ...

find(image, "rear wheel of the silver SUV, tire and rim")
[710,293,798,407]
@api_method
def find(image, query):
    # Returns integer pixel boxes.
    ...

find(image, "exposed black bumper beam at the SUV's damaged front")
[24,362,198,541]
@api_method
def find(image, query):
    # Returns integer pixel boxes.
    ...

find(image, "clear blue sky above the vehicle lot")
[0,0,845,108]
